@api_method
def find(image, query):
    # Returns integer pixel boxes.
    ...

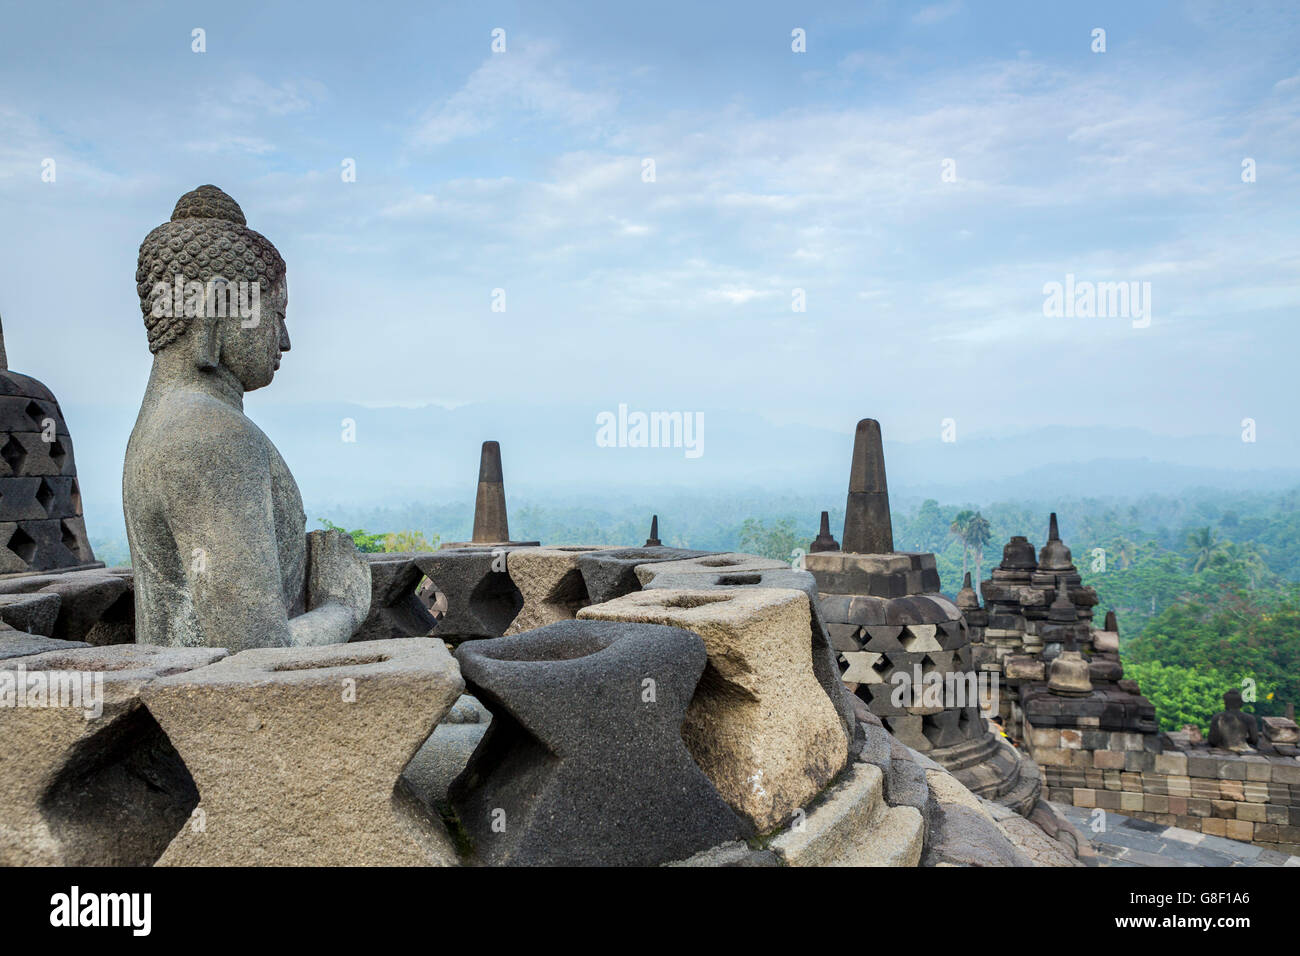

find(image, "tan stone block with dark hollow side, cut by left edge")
[0,639,226,866]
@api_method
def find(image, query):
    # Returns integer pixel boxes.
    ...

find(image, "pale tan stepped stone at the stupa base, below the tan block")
[771,763,924,866]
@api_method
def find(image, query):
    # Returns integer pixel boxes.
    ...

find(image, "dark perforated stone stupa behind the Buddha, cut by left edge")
[0,317,103,574]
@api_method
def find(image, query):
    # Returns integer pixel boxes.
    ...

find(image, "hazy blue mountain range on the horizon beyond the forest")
[71,395,1300,537]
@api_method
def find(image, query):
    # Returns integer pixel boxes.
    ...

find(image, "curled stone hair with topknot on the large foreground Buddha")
[135,186,285,352]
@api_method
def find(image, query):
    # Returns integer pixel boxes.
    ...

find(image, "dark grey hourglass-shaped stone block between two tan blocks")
[450,620,751,866]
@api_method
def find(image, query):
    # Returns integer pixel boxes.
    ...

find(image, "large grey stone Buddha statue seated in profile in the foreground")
[122,186,371,652]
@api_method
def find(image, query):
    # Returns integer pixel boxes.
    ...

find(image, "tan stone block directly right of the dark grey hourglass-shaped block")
[579,587,848,830]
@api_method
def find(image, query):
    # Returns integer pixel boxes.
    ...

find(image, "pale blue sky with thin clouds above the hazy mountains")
[0,1,1300,442]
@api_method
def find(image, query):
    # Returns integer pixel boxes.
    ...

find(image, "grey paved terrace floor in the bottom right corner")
[1053,804,1300,866]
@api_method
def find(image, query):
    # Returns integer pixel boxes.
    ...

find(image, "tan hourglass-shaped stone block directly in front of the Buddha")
[143,637,464,866]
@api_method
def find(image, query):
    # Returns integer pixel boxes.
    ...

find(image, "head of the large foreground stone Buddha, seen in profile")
[135,186,289,392]
